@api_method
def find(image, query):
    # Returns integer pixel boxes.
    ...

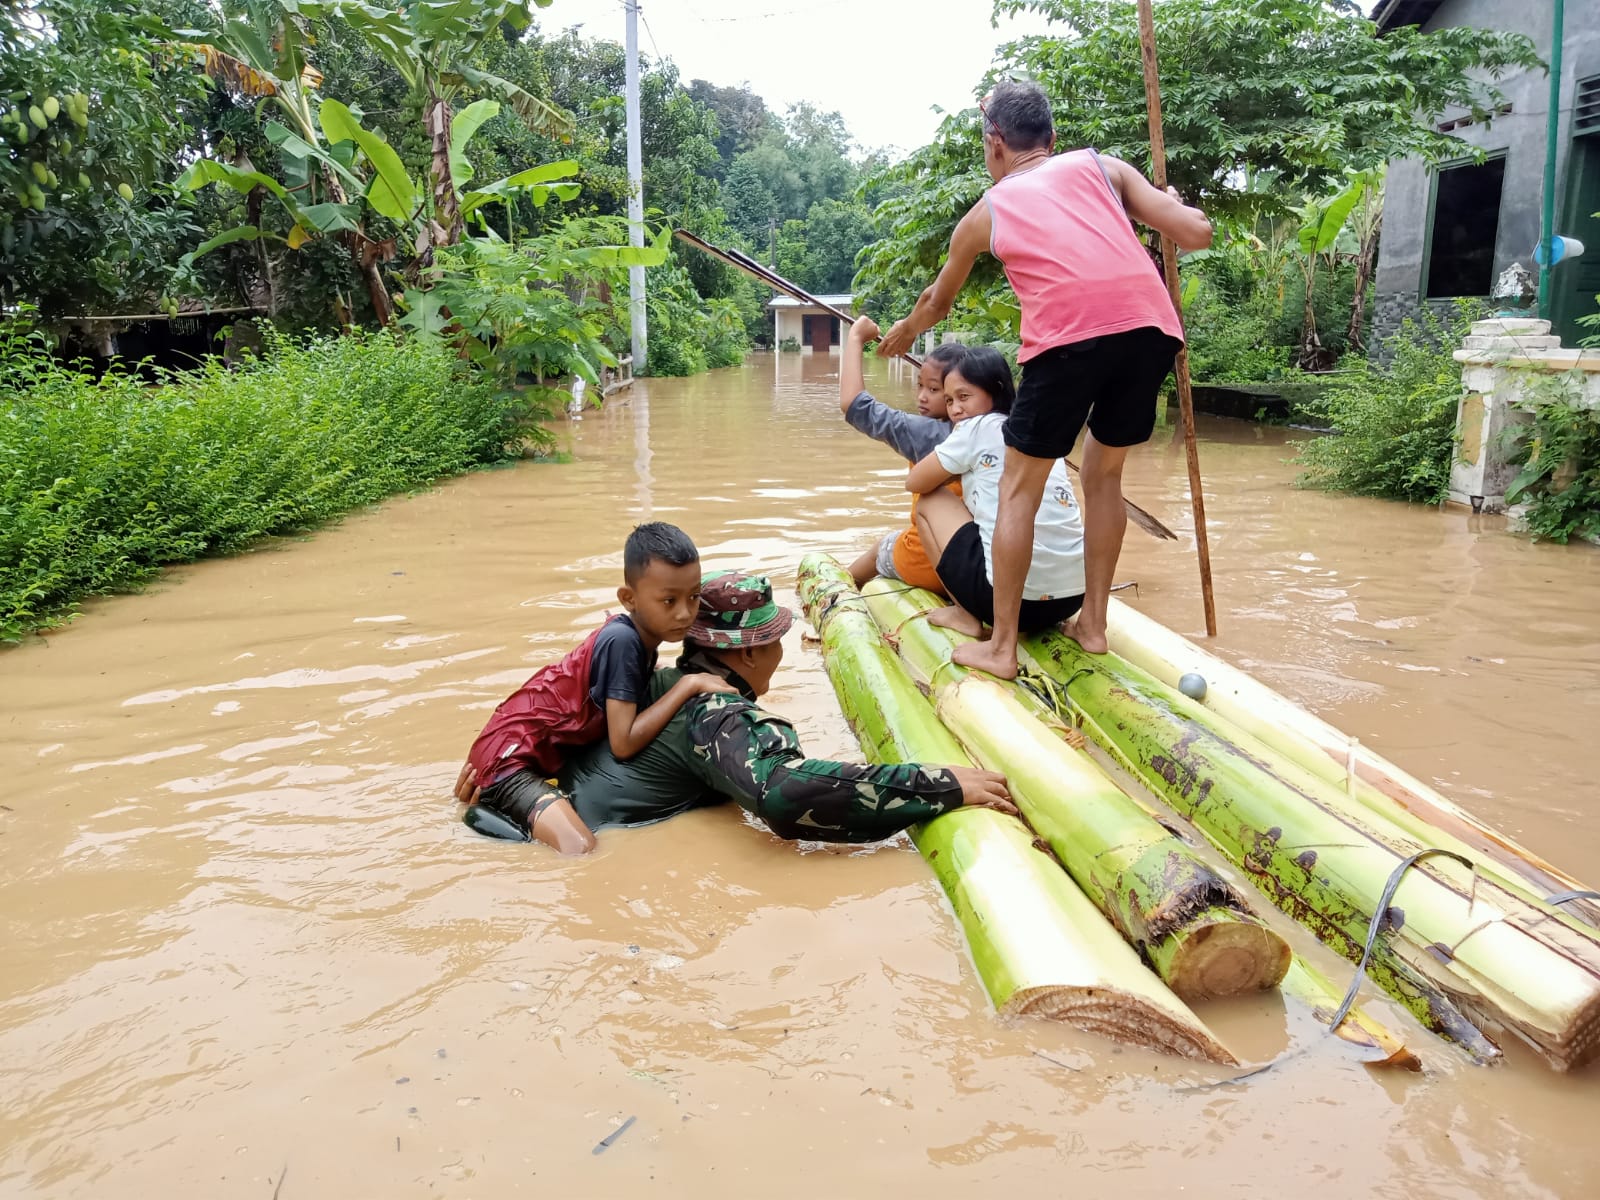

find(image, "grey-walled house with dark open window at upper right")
[1371,0,1600,346]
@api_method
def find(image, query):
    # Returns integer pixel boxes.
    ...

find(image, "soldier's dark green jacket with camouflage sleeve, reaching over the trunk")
[562,656,962,842]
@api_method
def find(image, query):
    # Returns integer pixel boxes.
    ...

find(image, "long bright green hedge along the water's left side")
[0,323,544,642]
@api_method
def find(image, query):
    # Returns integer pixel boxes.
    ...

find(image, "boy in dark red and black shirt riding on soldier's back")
[467,522,733,853]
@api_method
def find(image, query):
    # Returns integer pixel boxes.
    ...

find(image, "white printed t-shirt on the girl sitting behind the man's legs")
[933,413,1083,600]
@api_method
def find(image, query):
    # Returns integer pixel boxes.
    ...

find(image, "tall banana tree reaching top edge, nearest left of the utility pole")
[330,0,573,261]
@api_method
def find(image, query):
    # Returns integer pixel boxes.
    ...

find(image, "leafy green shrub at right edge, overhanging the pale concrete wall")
[1506,373,1600,542]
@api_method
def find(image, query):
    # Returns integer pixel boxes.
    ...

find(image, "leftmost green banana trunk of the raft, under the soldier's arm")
[798,555,1237,1064]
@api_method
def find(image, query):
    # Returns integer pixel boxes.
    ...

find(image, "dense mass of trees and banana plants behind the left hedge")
[0,0,872,374]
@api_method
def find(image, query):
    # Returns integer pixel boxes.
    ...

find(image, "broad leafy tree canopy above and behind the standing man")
[866,0,1541,315]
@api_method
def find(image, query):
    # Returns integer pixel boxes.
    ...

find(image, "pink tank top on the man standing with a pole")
[987,150,1184,363]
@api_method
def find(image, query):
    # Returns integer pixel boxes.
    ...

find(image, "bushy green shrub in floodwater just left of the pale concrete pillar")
[1298,310,1472,504]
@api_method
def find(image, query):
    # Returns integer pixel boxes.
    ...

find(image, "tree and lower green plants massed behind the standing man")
[858,0,1539,378]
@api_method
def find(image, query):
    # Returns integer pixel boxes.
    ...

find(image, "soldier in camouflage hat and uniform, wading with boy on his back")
[456,571,1016,842]
